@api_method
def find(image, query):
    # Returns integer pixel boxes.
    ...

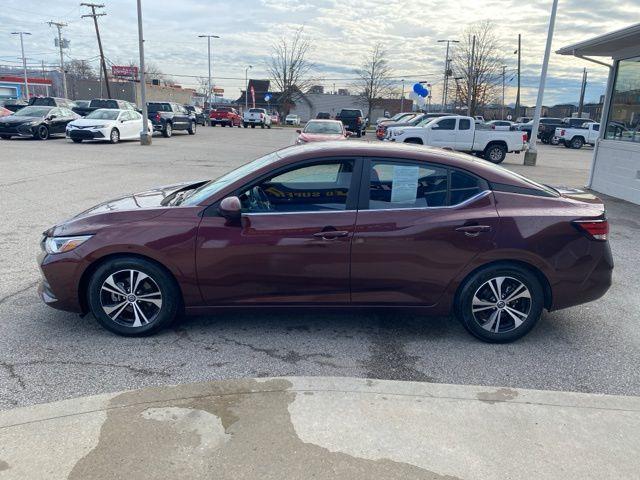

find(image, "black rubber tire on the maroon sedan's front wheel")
[87,257,181,337]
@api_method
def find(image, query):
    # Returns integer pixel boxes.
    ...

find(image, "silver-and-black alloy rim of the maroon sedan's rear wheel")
[471,276,531,333]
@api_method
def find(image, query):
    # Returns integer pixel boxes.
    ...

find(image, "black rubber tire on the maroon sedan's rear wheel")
[456,263,544,343]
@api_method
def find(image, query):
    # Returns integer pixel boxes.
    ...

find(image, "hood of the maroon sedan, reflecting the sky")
[45,180,208,236]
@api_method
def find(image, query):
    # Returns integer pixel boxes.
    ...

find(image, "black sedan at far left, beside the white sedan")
[0,105,78,140]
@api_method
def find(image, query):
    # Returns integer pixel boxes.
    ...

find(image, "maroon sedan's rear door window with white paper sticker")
[369,161,448,210]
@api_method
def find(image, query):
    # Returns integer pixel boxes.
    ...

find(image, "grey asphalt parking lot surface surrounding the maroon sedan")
[0,127,640,408]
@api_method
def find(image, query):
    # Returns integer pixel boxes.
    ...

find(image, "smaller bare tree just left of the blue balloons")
[355,43,395,118]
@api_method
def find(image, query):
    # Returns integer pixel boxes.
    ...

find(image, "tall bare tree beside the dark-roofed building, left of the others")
[267,27,313,115]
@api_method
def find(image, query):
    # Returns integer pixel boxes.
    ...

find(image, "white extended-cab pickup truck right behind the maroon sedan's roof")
[385,115,527,163]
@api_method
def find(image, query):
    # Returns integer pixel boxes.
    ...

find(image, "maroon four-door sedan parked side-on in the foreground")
[40,142,613,342]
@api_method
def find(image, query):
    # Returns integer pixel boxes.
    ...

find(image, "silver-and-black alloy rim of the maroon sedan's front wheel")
[100,269,162,328]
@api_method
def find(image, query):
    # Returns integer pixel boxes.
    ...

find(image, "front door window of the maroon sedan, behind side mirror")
[240,160,353,213]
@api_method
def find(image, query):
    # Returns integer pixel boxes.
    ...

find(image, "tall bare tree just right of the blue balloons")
[453,20,503,115]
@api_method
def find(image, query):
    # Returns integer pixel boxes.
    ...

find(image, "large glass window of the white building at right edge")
[605,57,640,142]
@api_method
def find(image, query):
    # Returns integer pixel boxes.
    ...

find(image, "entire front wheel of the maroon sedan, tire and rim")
[88,257,180,336]
